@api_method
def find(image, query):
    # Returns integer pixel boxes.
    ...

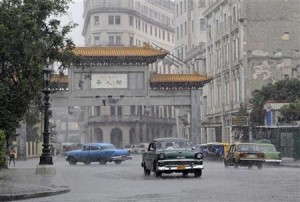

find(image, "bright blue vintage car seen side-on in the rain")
[66,143,132,165]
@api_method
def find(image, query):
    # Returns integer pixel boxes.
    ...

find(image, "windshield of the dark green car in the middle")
[156,140,193,150]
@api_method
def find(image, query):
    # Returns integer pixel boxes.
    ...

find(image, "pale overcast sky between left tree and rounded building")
[61,0,84,46]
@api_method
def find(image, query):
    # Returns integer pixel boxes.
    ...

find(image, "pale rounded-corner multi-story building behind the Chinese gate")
[78,0,177,147]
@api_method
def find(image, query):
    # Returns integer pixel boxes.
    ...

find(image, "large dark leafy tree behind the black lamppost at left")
[0,0,76,142]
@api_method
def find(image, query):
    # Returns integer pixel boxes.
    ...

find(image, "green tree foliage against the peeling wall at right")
[250,79,300,126]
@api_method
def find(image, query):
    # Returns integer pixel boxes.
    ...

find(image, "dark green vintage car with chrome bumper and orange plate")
[141,138,203,177]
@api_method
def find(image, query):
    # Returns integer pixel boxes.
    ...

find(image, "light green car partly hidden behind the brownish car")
[258,144,282,165]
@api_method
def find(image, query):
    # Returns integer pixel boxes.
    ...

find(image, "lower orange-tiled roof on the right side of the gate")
[150,73,213,90]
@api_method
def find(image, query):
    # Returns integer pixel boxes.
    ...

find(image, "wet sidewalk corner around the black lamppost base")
[0,157,70,201]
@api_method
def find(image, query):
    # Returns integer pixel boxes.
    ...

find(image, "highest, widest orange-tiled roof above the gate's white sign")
[74,43,168,65]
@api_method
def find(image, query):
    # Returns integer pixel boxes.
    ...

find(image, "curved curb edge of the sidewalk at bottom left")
[0,186,71,201]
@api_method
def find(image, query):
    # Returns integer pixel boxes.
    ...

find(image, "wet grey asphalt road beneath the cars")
[17,155,300,202]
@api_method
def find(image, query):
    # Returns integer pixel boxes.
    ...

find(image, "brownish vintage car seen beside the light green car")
[224,143,265,169]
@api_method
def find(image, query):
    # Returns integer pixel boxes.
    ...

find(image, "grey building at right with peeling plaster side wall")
[203,0,300,142]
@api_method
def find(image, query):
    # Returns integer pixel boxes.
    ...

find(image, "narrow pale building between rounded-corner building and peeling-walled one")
[174,0,206,143]
